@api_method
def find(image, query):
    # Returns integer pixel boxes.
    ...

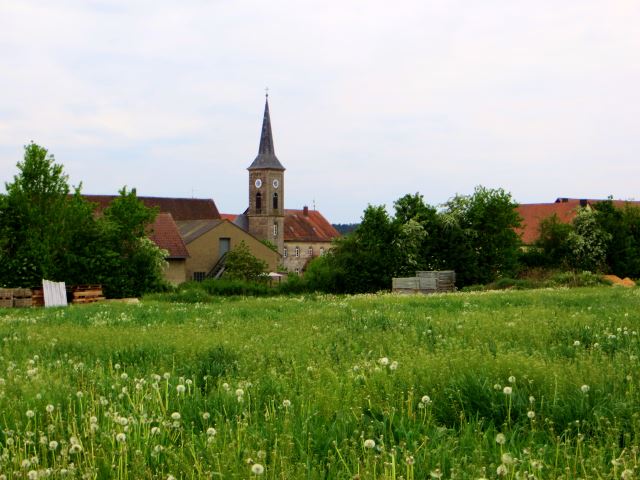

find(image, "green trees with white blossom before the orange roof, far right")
[522,199,640,278]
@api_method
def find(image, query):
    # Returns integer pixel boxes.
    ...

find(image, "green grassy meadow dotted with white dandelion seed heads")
[0,287,640,480]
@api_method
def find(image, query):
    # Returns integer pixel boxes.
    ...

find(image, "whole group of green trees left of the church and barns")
[0,143,166,297]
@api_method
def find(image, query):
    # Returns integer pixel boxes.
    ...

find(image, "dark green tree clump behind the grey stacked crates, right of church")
[305,187,521,293]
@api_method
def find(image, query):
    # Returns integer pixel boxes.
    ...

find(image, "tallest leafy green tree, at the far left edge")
[0,143,92,287]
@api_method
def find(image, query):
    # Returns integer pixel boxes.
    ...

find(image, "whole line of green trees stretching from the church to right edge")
[303,186,640,293]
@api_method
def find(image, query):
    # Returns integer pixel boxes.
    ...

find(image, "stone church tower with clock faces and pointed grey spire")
[247,94,285,254]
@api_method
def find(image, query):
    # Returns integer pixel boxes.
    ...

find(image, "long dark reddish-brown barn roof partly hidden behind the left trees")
[82,195,220,222]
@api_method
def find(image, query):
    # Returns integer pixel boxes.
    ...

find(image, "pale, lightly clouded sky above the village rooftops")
[0,0,640,223]
